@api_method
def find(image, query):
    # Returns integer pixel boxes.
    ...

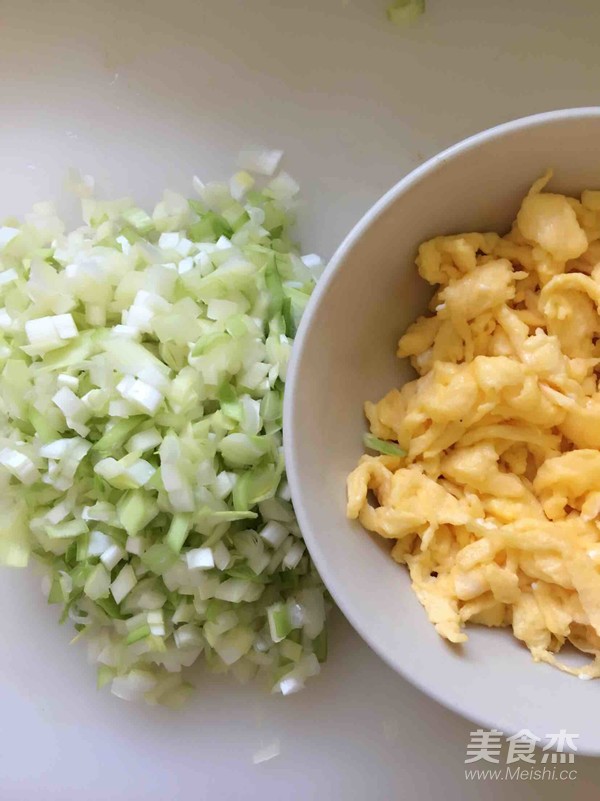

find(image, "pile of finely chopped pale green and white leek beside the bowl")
[0,152,326,706]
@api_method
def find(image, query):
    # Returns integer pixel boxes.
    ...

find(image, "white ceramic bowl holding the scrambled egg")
[285,108,600,754]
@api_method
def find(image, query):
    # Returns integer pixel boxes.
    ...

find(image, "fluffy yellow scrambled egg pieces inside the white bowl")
[348,173,600,678]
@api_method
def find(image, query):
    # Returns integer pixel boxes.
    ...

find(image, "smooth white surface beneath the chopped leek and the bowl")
[0,0,600,801]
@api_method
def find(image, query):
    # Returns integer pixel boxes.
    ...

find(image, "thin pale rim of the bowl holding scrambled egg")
[283,106,600,756]
